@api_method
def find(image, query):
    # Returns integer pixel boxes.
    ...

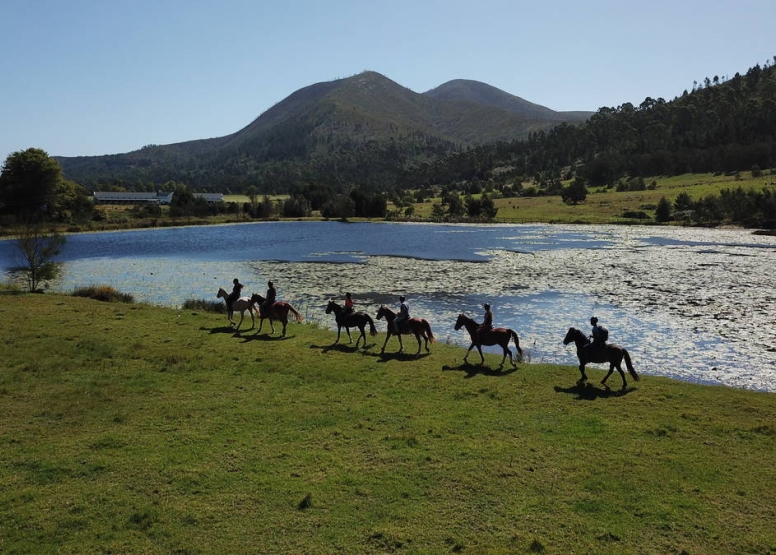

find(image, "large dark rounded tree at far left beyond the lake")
[0,148,64,221]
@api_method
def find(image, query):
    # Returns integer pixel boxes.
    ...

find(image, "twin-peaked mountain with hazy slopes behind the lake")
[57,71,592,191]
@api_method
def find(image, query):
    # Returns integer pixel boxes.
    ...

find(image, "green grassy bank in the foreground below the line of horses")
[0,292,776,554]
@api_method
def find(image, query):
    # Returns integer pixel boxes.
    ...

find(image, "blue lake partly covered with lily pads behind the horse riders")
[0,222,776,391]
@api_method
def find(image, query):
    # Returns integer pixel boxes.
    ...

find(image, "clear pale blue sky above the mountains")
[0,0,776,163]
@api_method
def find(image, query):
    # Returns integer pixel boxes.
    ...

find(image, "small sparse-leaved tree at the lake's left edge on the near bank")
[14,223,65,293]
